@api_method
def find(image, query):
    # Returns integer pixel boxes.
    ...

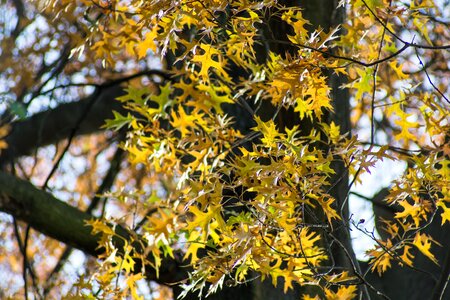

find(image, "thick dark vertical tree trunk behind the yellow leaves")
[174,0,357,300]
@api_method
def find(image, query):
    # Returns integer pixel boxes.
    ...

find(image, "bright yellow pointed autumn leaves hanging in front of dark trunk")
[0,0,450,299]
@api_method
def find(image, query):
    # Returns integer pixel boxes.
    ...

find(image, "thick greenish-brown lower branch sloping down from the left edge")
[0,172,189,284]
